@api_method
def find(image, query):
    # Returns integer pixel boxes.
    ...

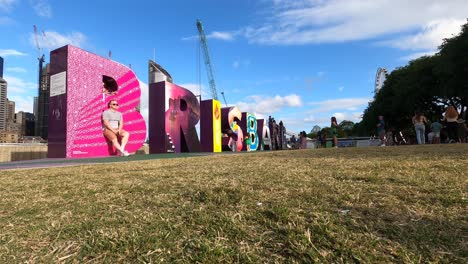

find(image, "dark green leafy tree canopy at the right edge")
[355,18,468,135]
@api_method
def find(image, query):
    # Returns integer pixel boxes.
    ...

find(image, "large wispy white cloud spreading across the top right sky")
[243,0,468,49]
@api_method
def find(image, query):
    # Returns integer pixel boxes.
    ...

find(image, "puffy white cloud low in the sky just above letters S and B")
[235,94,303,116]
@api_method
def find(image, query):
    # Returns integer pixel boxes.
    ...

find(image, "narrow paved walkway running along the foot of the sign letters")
[0,152,218,170]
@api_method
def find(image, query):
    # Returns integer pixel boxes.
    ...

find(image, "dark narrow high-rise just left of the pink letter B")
[35,63,50,139]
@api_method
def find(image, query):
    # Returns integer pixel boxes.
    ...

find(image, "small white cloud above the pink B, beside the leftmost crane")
[29,31,86,50]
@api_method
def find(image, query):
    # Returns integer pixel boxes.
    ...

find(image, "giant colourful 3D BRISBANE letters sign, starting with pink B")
[48,45,278,158]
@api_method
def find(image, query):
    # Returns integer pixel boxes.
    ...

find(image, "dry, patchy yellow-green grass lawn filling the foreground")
[0,144,468,263]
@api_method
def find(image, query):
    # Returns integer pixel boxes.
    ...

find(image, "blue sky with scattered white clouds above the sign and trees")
[0,0,468,132]
